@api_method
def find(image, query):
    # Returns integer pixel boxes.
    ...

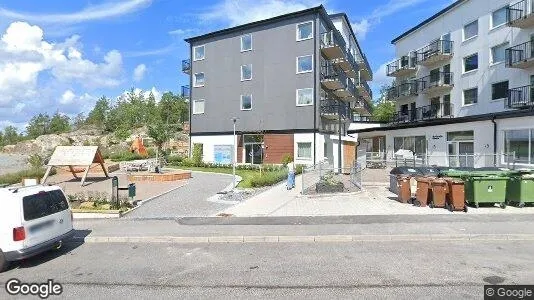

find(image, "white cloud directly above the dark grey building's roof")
[200,0,324,26]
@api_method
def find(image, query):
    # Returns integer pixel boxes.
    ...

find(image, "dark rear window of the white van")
[22,190,69,221]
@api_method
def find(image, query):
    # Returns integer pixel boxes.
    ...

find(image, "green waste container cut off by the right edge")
[506,174,534,207]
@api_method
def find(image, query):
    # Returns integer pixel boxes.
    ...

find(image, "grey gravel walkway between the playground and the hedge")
[125,172,236,218]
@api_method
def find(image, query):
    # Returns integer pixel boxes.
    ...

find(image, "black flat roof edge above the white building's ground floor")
[348,110,534,133]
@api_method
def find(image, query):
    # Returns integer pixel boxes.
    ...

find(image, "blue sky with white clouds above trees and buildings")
[0,0,452,130]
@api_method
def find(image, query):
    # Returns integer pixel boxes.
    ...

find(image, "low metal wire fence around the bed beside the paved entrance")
[301,161,362,195]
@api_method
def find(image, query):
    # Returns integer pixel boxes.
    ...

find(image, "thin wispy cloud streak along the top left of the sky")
[0,0,152,24]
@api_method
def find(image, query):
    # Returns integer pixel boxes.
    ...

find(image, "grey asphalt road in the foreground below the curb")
[0,241,534,299]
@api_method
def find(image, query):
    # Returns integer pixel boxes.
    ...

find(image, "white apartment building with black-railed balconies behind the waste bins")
[350,0,534,166]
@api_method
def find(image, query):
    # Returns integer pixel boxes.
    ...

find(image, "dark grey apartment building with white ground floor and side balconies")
[182,5,372,164]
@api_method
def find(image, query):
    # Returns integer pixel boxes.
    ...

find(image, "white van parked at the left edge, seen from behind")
[0,185,74,272]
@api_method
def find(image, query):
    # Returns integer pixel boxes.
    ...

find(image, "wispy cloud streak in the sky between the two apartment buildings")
[351,0,428,39]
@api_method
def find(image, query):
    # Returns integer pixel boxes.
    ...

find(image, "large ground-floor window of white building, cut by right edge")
[504,129,534,164]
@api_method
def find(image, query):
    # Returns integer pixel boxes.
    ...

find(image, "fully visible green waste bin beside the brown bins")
[465,176,508,208]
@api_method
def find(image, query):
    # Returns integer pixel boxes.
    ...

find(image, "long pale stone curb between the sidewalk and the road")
[72,234,534,244]
